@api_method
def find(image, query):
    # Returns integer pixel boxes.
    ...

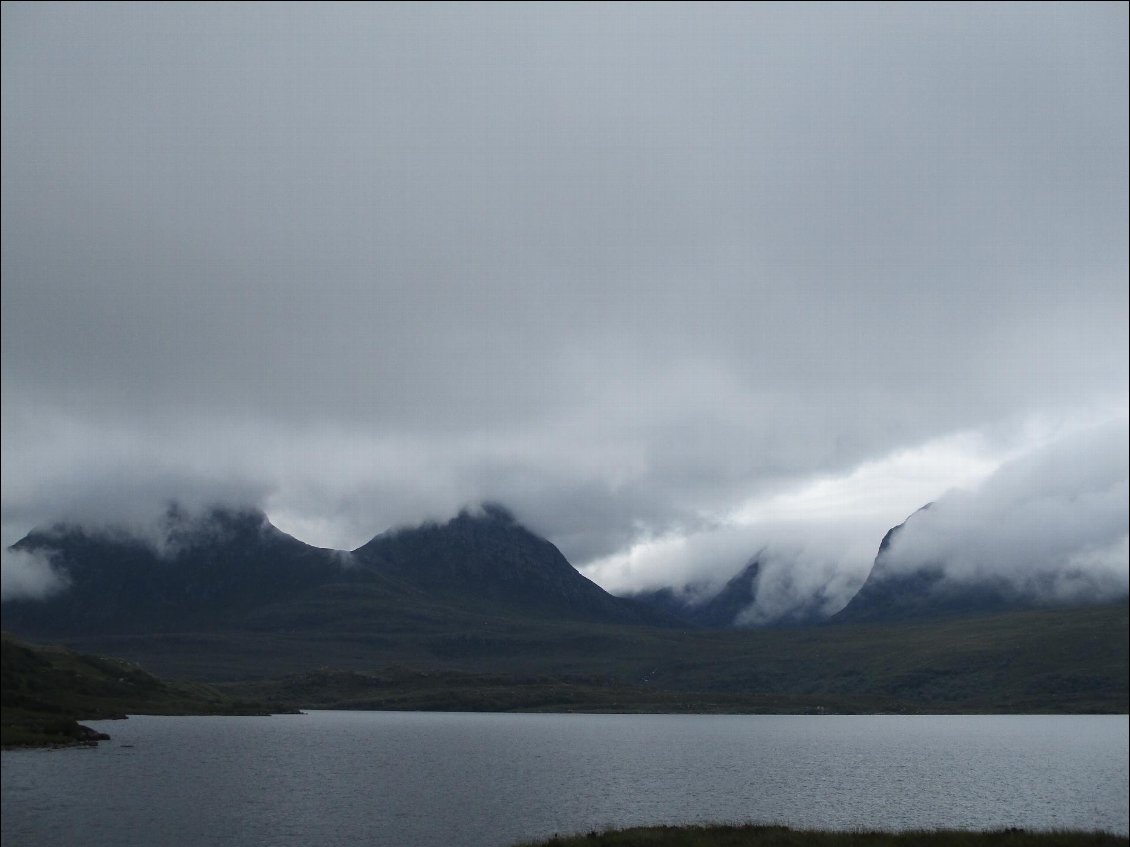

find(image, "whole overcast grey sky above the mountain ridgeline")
[0,2,1128,618]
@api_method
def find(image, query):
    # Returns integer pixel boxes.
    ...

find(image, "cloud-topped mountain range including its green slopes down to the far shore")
[2,506,1130,711]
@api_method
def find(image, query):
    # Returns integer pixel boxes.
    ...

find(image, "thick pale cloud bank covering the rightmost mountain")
[881,421,1130,602]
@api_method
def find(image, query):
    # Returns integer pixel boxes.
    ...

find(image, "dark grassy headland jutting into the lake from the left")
[0,632,280,746]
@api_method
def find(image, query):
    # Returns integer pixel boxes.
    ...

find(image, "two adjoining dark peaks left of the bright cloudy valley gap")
[3,507,673,639]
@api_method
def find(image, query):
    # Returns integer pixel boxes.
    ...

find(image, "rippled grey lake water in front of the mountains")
[2,711,1130,847]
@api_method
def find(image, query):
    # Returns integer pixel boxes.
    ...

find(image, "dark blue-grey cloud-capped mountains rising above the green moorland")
[3,504,1120,637]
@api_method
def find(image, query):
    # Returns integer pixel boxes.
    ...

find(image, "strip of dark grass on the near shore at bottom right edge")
[515,824,1130,847]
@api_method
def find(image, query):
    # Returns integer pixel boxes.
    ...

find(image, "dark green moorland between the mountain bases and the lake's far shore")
[55,604,1130,714]
